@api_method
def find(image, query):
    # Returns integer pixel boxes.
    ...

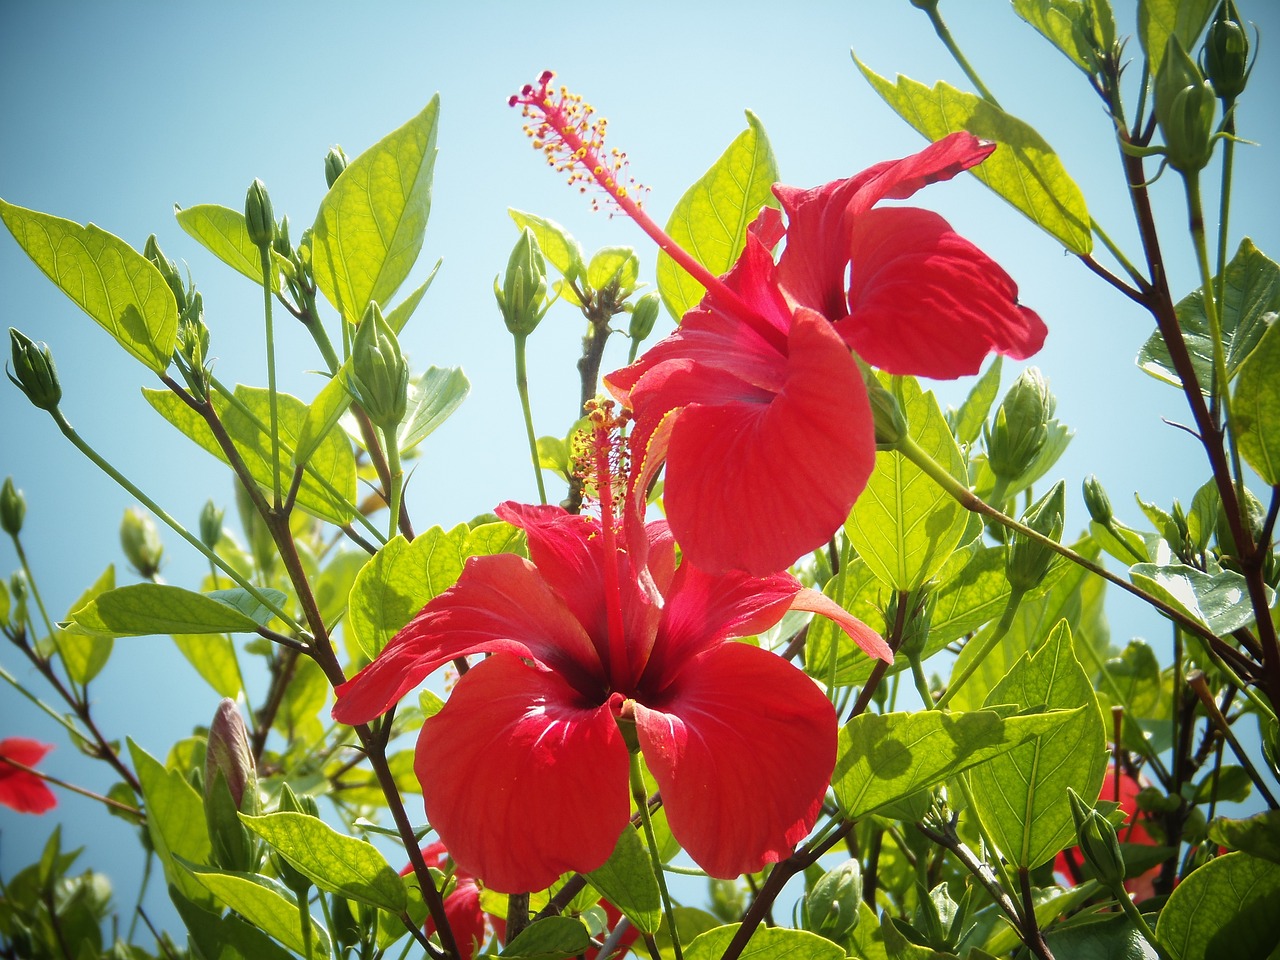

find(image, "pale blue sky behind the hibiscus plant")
[0,0,1280,942]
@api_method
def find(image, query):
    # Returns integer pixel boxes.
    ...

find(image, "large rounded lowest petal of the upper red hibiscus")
[664,308,876,576]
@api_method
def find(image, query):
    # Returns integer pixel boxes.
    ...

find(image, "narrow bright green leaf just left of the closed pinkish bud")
[128,740,212,909]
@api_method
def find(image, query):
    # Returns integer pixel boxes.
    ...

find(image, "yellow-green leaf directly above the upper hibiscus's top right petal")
[854,56,1093,255]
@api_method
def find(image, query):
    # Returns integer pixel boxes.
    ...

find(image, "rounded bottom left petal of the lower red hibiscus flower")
[413,653,631,893]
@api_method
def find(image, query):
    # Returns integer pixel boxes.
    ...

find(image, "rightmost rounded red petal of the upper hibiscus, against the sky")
[837,207,1046,379]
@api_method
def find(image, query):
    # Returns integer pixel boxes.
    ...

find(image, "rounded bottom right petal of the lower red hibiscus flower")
[635,643,836,878]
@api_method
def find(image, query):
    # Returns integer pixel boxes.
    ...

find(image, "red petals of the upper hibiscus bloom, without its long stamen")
[605,133,1046,573]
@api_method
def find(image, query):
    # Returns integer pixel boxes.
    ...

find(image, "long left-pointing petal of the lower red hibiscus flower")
[333,553,604,724]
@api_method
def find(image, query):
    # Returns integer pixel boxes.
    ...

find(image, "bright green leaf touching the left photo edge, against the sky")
[0,200,178,374]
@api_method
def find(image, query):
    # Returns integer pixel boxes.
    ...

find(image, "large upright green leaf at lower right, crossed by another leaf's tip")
[969,621,1107,869]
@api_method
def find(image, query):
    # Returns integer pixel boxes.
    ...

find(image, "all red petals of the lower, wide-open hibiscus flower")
[333,481,891,892]
